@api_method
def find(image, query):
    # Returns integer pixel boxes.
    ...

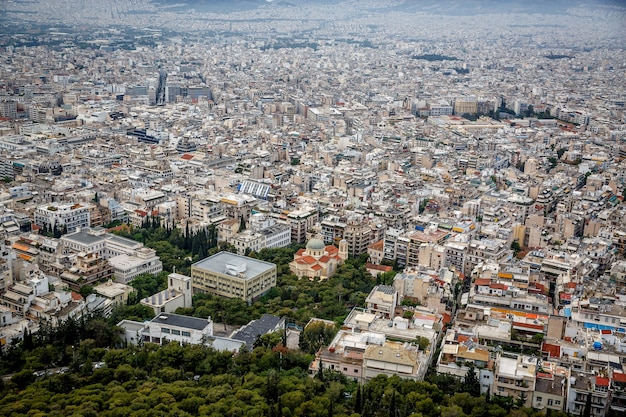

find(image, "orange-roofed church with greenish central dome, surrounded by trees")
[289,237,348,281]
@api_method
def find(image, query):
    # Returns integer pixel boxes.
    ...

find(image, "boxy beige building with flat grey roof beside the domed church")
[191,252,276,302]
